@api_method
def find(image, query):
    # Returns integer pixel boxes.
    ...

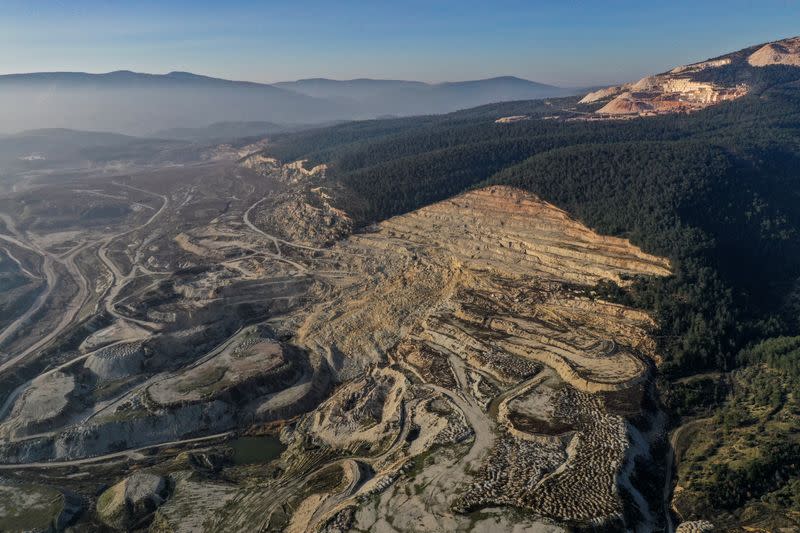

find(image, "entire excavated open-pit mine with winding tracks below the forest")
[0,145,670,532]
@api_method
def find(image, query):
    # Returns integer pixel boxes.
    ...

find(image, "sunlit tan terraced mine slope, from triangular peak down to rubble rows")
[276,187,669,531]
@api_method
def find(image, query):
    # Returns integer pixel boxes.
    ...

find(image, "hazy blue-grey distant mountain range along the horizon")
[0,71,582,137]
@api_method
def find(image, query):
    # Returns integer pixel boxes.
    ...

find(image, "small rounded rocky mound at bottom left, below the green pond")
[97,472,167,530]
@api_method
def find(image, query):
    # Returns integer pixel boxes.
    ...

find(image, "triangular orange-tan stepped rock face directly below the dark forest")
[382,186,669,284]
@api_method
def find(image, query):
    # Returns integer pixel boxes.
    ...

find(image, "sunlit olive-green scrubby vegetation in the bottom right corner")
[676,365,800,530]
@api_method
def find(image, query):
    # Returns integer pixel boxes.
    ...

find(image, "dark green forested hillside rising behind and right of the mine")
[260,80,800,523]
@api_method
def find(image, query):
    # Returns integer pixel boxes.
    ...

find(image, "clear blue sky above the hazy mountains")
[0,0,800,86]
